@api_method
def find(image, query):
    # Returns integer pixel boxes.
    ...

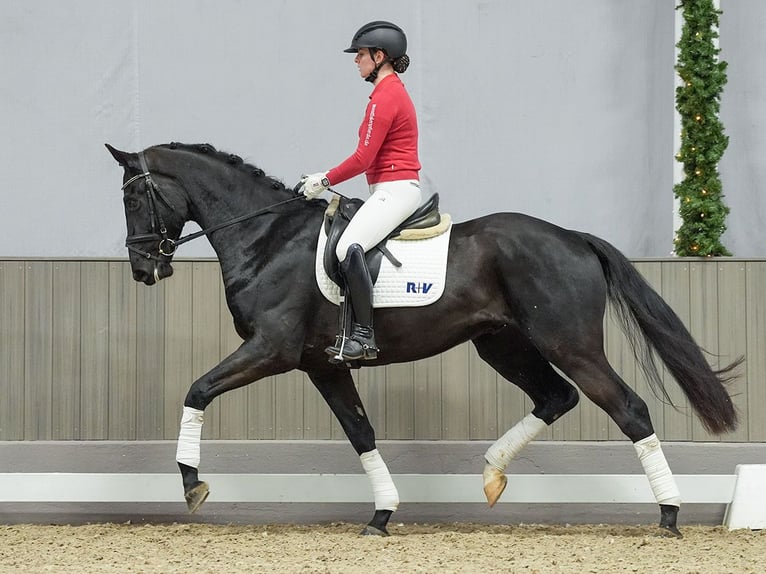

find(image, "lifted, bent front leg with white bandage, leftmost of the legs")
[176,340,287,513]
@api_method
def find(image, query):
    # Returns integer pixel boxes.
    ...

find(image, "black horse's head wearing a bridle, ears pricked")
[106,144,185,285]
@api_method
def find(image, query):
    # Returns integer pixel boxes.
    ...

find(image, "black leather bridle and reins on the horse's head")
[120,152,305,272]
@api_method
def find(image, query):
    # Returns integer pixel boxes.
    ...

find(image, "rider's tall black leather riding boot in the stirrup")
[326,243,378,361]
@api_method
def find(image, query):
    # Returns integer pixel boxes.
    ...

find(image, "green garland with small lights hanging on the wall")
[673,0,731,257]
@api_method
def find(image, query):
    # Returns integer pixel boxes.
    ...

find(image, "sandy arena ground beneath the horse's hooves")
[0,523,766,574]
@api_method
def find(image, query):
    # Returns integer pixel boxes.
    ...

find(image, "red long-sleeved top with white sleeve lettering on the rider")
[327,74,420,185]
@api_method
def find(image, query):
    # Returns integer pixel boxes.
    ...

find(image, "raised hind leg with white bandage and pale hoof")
[473,327,578,506]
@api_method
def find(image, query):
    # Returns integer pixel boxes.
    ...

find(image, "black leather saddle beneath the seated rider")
[323,193,441,288]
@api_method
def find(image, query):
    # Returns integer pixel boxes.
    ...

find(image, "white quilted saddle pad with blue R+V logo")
[315,225,452,308]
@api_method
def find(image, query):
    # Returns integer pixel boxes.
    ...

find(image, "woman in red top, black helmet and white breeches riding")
[303,20,422,361]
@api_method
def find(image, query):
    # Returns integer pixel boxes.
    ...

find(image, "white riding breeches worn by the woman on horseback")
[335,179,423,261]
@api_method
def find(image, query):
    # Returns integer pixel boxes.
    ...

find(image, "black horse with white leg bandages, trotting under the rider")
[106,143,742,537]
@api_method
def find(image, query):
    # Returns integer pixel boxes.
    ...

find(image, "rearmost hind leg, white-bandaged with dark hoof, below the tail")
[555,347,681,537]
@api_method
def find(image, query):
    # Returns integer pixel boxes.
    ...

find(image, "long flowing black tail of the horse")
[580,233,743,434]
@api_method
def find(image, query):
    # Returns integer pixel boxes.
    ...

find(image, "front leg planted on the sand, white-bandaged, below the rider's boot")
[308,368,399,536]
